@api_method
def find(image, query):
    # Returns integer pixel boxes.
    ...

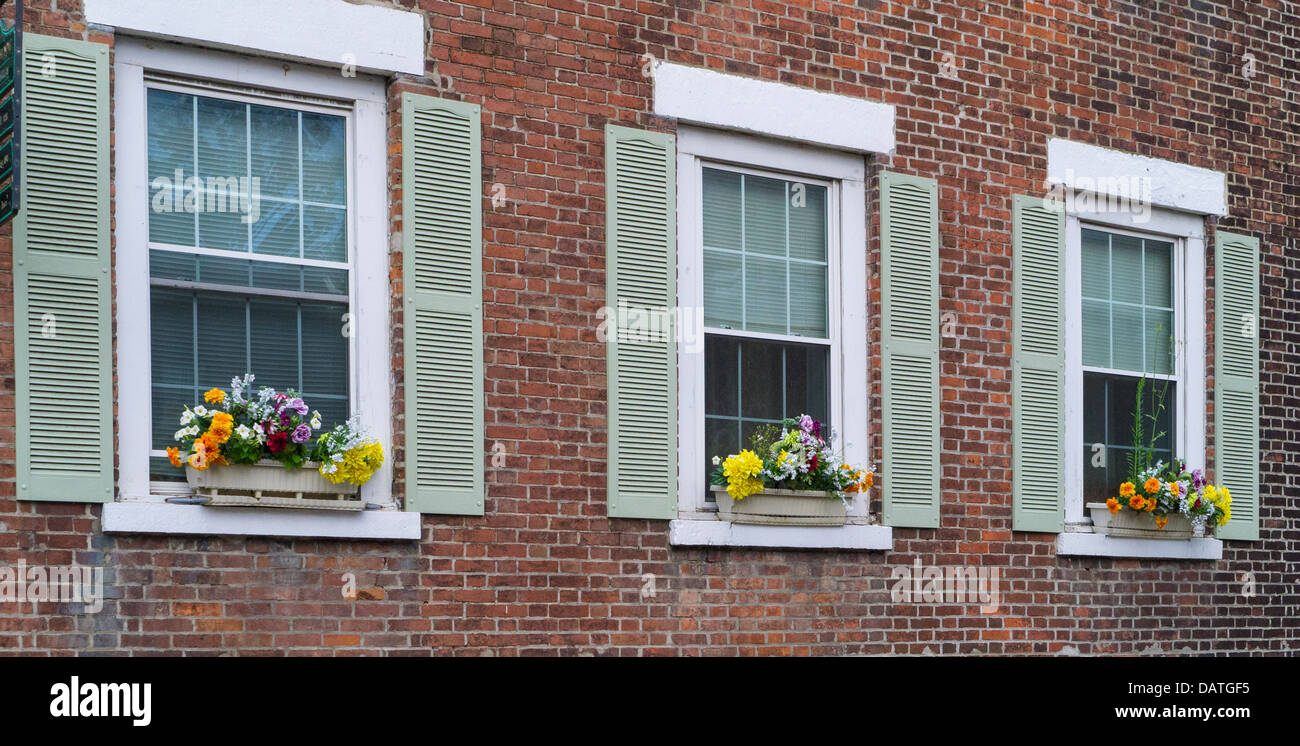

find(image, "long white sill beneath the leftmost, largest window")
[104,502,420,541]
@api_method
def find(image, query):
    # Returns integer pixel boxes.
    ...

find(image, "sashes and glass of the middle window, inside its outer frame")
[702,164,835,488]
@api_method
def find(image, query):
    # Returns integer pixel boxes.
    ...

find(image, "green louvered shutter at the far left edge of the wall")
[13,34,113,503]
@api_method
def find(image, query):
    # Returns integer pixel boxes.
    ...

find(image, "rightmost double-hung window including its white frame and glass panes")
[1066,209,1205,524]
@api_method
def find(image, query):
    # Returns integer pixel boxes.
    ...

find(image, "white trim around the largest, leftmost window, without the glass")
[113,39,395,522]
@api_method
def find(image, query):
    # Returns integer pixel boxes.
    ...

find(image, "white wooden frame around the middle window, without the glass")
[677,126,868,524]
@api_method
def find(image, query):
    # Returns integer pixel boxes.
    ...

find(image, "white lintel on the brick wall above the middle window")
[653,62,894,153]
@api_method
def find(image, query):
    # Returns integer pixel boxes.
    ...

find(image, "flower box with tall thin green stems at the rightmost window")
[1088,377,1232,539]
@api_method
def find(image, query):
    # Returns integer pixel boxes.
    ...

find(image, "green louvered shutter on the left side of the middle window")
[605,125,677,519]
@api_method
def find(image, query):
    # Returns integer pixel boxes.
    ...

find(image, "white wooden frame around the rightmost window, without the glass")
[1065,200,1206,530]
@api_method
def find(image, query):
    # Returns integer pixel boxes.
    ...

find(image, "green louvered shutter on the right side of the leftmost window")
[402,94,486,516]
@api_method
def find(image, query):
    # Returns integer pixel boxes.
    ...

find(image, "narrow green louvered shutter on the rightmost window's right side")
[1214,231,1260,541]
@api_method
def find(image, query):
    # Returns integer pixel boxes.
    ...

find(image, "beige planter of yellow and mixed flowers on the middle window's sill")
[710,415,875,526]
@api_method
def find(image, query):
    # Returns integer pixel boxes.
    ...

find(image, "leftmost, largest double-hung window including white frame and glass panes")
[113,39,391,506]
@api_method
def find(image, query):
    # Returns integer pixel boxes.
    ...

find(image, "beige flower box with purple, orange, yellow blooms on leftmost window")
[166,374,384,511]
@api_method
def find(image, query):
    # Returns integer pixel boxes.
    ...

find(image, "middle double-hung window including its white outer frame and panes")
[677,126,867,517]
